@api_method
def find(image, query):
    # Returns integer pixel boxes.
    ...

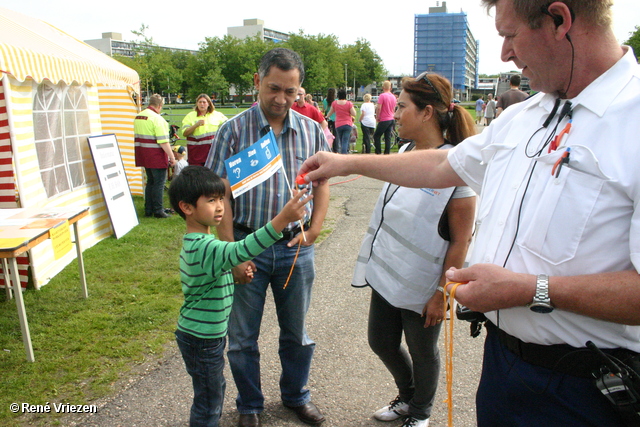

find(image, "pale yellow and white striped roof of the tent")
[0,8,139,88]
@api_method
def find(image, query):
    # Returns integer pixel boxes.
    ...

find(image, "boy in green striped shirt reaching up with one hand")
[169,166,313,427]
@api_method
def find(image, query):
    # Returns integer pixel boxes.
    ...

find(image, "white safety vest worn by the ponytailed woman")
[351,145,456,314]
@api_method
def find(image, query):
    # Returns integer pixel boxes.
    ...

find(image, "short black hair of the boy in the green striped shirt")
[169,166,225,218]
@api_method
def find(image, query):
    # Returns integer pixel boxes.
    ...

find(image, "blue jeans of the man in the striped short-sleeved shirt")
[227,234,315,414]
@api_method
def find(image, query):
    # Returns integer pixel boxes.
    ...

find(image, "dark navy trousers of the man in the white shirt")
[476,326,623,427]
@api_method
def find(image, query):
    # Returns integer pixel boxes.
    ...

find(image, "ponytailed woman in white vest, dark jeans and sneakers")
[352,73,476,427]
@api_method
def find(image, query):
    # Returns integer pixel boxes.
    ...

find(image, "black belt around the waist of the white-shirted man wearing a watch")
[485,321,638,378]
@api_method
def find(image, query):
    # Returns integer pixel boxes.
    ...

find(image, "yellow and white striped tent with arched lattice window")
[0,8,142,288]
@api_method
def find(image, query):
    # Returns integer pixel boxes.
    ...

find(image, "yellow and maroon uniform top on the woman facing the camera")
[182,110,227,166]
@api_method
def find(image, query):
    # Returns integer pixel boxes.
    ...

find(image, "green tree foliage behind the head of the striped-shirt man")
[116,24,386,100]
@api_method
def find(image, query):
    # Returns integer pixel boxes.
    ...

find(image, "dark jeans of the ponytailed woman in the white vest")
[368,290,441,420]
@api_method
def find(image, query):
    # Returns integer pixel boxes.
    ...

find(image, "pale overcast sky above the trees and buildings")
[0,0,640,75]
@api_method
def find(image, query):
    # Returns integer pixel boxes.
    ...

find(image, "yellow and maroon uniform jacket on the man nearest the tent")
[133,108,169,169]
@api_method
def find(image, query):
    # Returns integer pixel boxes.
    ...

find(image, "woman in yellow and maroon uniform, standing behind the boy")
[182,93,227,166]
